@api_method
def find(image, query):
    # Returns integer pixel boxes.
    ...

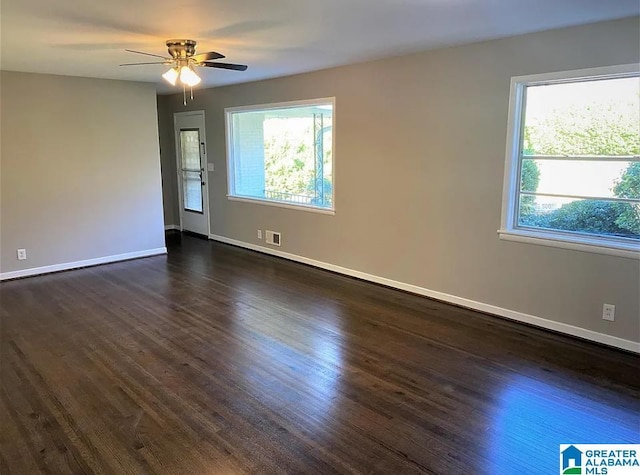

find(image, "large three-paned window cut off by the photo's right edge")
[499,65,640,257]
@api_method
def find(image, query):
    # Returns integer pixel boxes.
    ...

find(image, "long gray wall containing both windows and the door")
[160,18,640,341]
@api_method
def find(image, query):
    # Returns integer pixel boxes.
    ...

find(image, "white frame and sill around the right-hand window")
[498,63,640,259]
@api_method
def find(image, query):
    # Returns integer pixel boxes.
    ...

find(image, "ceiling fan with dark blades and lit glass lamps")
[120,40,247,105]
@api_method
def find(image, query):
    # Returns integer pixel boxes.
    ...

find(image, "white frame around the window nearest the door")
[224,97,336,215]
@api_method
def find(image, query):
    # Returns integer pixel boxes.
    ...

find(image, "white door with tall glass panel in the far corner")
[173,111,209,237]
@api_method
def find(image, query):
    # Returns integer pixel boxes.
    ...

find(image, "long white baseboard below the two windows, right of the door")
[209,234,640,353]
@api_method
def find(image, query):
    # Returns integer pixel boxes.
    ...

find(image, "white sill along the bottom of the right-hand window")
[498,229,640,259]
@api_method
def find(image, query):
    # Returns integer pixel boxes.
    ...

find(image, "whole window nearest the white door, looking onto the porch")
[225,99,334,212]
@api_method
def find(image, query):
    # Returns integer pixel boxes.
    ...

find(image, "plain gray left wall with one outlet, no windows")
[0,71,165,273]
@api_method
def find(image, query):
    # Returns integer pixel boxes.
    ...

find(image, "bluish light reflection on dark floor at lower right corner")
[488,376,640,474]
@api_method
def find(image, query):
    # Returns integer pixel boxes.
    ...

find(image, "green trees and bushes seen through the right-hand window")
[519,95,640,238]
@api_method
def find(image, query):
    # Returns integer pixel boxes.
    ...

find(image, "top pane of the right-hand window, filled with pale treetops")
[522,77,640,156]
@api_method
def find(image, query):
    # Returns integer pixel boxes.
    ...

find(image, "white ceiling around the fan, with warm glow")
[0,0,640,92]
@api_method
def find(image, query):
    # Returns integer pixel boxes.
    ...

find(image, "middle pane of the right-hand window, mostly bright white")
[520,159,640,199]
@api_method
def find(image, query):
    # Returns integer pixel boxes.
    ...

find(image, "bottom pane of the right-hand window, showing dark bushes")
[518,195,640,239]
